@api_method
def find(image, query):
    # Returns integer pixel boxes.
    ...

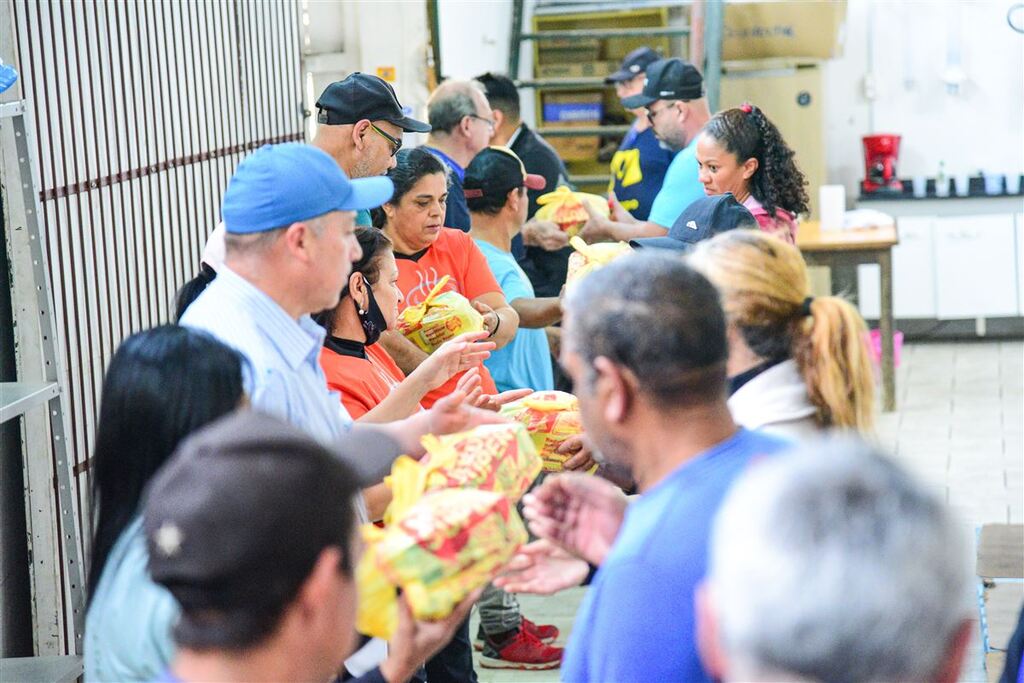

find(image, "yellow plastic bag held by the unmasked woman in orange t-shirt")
[397,275,483,353]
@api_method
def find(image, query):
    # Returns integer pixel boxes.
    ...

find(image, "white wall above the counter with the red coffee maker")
[824,0,1024,197]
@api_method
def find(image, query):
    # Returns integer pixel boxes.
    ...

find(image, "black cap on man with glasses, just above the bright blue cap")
[316,72,430,133]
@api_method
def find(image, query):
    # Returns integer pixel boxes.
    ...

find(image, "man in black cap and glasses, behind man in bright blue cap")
[312,72,430,226]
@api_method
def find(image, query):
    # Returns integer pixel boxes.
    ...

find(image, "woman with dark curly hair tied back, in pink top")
[696,104,809,244]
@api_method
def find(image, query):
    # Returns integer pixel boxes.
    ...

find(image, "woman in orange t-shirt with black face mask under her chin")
[313,227,495,518]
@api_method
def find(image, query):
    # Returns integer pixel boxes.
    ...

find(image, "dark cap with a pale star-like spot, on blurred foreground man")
[143,410,400,612]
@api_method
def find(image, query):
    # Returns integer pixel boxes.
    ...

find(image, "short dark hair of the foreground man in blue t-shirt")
[564,253,728,411]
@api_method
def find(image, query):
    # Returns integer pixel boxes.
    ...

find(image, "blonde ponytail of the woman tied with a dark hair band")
[792,297,874,433]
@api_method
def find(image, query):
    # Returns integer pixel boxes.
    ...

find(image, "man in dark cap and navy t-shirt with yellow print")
[604,47,676,220]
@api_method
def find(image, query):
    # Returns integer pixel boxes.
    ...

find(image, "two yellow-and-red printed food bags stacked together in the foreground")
[356,423,542,638]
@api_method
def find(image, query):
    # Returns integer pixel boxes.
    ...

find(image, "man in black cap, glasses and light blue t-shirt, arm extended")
[581,57,711,242]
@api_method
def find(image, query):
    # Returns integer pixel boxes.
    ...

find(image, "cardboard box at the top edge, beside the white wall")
[722,0,846,60]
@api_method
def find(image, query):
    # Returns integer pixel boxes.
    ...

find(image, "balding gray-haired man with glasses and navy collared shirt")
[425,81,495,232]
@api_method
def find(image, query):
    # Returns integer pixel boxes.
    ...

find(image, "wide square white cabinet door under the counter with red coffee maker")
[937,214,1019,319]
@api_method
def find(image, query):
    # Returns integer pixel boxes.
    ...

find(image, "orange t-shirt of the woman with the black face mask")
[319,344,406,420]
